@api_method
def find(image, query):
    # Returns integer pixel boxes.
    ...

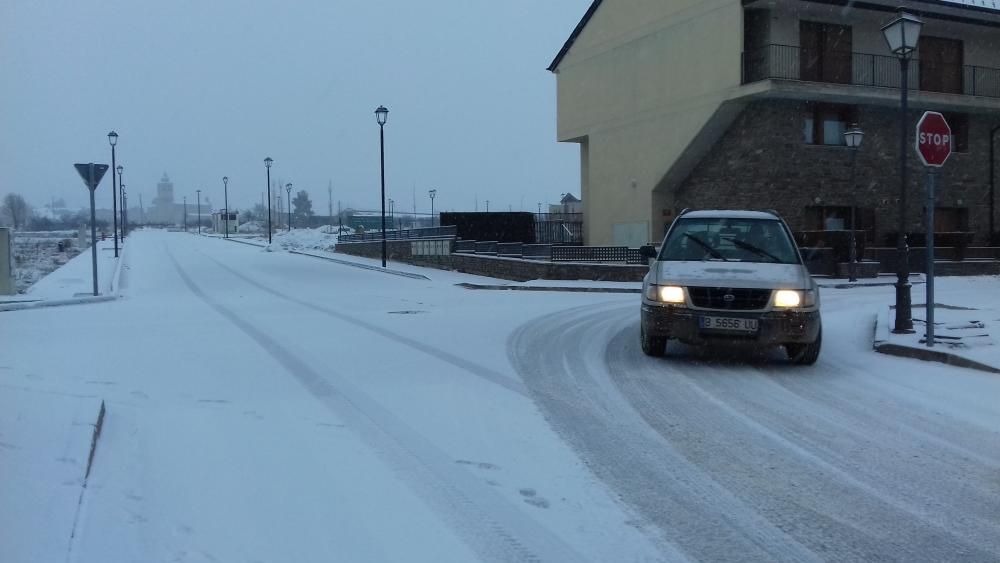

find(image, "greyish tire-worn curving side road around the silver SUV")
[511,288,1000,561]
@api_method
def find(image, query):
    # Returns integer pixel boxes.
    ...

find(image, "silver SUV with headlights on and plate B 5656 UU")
[641,210,823,364]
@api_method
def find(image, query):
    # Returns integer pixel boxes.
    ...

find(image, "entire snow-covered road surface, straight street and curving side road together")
[0,231,1000,562]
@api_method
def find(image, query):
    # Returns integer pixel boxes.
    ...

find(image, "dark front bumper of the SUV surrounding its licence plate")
[642,303,821,346]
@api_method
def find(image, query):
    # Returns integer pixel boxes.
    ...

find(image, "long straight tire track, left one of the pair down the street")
[167,250,587,562]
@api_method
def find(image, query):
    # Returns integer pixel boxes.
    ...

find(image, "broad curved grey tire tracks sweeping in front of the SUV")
[509,307,1000,561]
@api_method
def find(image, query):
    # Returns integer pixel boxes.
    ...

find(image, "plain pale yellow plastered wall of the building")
[556,0,743,246]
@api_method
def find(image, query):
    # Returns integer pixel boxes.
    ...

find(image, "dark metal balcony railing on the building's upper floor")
[743,45,1000,98]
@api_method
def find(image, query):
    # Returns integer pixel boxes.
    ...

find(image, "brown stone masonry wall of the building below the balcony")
[676,100,1000,244]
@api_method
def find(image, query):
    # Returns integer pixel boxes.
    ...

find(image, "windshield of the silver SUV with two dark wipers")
[660,217,799,264]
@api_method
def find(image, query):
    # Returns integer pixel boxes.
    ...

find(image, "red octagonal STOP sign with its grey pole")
[916,111,952,347]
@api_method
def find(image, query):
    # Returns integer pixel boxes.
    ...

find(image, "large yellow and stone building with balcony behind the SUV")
[549,0,1000,247]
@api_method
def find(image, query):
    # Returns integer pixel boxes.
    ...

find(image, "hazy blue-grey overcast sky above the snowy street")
[0,0,590,217]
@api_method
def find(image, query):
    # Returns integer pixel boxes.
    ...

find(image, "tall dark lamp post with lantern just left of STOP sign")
[882,11,924,333]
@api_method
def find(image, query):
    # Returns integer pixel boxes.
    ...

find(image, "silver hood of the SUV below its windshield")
[656,261,812,289]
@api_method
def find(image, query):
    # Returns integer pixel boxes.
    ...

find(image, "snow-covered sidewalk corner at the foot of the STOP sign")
[874,277,1000,373]
